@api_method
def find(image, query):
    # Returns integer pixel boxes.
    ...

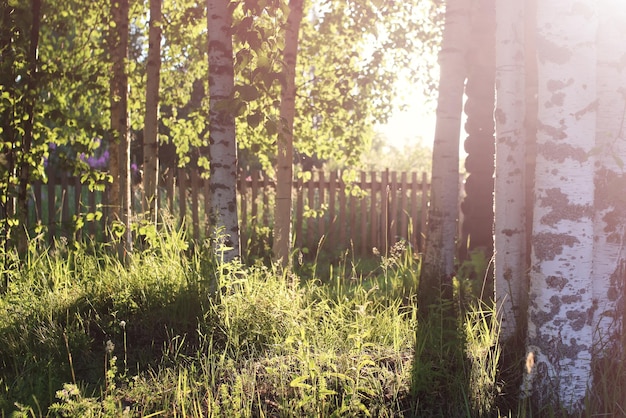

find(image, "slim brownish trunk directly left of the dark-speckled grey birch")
[143,0,161,225]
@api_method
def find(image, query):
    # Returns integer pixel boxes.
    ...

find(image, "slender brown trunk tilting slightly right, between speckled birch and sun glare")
[273,0,303,267]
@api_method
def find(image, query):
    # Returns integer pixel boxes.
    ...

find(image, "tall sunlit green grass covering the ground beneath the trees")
[0,227,624,417]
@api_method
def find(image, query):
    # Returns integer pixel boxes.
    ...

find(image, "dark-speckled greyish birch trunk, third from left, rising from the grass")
[207,0,241,262]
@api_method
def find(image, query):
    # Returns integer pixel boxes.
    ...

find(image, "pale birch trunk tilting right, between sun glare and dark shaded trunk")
[418,0,470,315]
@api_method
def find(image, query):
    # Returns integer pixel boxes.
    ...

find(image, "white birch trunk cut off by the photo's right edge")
[593,0,626,357]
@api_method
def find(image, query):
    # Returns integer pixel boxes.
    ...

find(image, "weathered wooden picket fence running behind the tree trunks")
[29,169,430,255]
